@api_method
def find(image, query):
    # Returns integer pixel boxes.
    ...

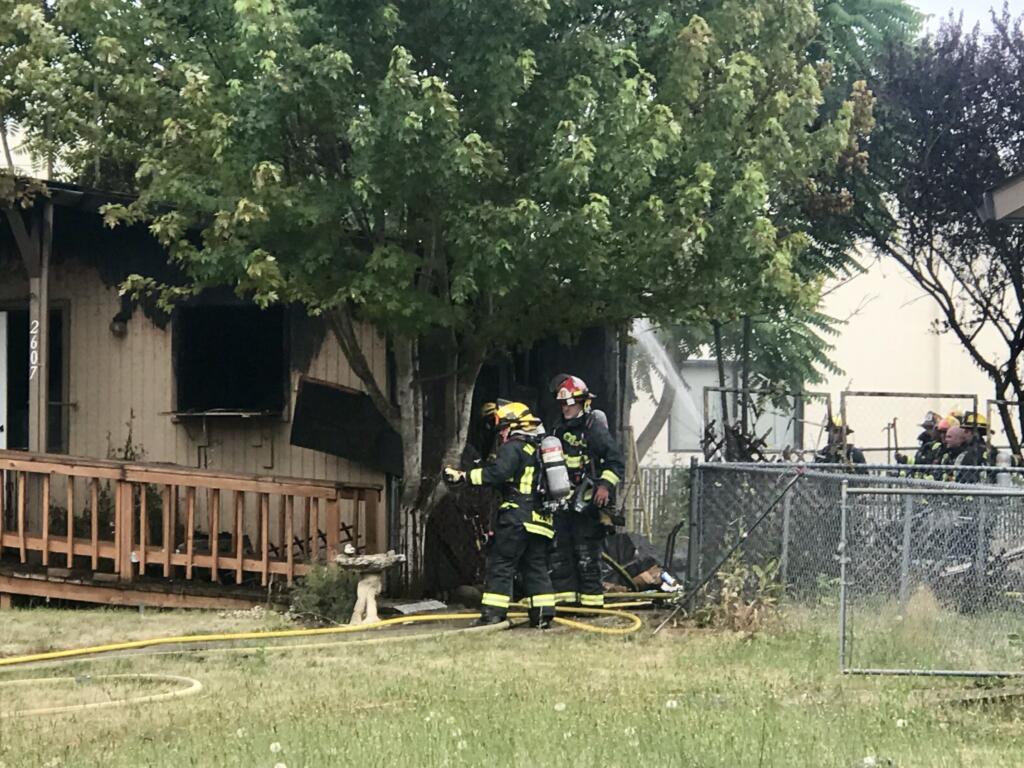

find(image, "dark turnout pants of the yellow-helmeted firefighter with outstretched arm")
[480,512,555,625]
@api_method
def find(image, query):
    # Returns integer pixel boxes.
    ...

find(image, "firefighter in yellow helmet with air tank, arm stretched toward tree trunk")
[444,402,555,629]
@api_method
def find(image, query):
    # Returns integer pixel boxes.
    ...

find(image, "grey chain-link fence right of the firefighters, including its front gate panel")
[645,462,1024,675]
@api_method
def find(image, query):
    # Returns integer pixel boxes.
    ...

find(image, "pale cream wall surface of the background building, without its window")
[631,258,998,466]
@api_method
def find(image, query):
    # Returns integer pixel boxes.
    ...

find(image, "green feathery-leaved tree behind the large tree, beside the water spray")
[633,0,921,458]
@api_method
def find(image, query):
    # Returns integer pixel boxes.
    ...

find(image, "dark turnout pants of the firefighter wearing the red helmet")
[551,507,605,608]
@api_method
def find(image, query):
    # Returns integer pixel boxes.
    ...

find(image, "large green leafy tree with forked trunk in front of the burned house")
[8,0,869,565]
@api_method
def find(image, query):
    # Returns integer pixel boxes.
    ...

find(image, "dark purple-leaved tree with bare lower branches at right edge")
[862,9,1024,456]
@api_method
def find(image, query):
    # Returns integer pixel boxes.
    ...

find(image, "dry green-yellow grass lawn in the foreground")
[0,609,1024,768]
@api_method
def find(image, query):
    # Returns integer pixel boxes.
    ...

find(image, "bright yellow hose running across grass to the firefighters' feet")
[0,606,643,668]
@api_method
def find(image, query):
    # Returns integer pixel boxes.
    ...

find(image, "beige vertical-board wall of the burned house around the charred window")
[0,262,387,543]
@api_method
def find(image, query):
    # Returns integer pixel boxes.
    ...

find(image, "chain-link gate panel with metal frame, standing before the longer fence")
[840,481,1024,677]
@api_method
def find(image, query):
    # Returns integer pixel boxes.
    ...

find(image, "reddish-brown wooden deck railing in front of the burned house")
[0,451,381,586]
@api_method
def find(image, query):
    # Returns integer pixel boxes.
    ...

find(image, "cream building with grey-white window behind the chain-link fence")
[631,258,998,466]
